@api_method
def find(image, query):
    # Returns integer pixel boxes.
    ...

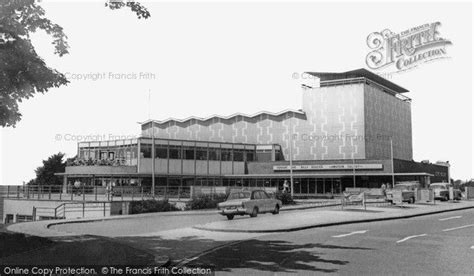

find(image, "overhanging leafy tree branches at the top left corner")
[0,0,150,127]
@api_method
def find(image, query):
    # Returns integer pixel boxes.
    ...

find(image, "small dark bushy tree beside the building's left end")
[28,152,66,186]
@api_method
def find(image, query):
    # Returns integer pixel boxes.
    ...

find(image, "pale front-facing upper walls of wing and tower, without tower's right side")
[142,84,365,160]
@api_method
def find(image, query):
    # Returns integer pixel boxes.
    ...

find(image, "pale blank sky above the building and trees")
[0,0,473,185]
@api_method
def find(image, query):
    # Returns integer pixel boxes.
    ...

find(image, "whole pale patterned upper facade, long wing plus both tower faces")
[142,82,412,160]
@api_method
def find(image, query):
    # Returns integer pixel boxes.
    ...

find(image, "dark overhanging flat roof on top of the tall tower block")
[305,68,409,93]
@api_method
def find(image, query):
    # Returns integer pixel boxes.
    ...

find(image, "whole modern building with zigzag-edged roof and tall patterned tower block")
[60,69,448,196]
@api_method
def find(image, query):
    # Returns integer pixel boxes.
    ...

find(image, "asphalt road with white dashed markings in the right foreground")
[186,209,474,275]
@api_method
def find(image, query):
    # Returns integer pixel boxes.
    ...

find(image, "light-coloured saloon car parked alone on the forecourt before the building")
[217,190,282,220]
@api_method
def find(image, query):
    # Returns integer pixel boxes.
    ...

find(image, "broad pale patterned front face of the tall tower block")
[295,84,366,160]
